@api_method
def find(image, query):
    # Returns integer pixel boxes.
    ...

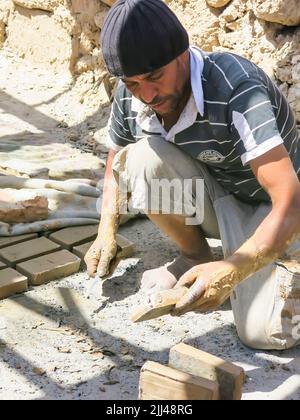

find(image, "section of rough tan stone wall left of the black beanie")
[0,0,108,75]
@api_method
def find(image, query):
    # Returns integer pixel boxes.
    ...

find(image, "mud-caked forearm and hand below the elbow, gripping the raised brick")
[174,207,300,315]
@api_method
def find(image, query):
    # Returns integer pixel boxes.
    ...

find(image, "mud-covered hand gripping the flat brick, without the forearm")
[172,261,240,315]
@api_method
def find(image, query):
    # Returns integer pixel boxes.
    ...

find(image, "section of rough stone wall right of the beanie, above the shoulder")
[166,0,300,124]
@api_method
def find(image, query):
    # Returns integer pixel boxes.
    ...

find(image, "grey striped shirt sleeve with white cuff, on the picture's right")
[229,79,283,165]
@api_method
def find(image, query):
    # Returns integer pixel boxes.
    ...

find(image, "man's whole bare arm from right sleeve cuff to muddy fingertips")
[175,152,300,315]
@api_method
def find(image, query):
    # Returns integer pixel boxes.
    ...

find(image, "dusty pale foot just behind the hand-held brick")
[141,255,213,294]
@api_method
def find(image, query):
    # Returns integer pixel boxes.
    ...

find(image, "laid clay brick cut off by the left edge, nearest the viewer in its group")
[0,268,28,299]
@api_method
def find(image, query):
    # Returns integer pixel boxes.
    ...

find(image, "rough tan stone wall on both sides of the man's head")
[0,0,300,123]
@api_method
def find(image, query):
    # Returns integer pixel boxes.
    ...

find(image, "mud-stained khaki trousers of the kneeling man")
[113,136,300,350]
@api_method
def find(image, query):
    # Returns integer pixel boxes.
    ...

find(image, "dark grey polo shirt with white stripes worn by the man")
[108,47,300,202]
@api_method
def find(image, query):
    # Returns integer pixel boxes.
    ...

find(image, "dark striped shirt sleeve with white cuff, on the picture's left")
[106,82,135,151]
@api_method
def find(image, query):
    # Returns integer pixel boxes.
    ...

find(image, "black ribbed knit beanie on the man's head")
[101,0,189,77]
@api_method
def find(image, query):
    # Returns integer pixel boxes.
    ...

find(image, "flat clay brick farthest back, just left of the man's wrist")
[49,225,98,251]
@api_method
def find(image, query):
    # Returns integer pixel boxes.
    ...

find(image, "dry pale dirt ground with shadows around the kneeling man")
[0,51,300,400]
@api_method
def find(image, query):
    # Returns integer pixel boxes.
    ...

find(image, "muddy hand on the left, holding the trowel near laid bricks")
[84,234,118,277]
